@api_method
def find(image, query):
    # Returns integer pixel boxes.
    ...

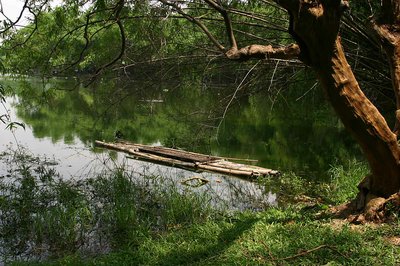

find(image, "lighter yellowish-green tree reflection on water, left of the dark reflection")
[10,75,219,148]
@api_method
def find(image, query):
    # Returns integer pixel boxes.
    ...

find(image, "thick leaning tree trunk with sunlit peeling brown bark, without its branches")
[277,0,400,200]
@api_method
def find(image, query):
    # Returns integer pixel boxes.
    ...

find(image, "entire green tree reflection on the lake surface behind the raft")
[6,66,358,179]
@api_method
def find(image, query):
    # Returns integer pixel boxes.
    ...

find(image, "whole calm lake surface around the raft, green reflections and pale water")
[0,74,360,209]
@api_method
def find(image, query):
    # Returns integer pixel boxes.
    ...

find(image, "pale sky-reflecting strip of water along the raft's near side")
[0,92,277,210]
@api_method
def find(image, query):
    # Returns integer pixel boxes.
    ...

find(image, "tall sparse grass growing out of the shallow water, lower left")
[0,149,218,262]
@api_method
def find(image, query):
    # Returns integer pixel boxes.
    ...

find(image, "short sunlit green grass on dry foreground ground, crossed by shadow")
[25,209,400,265]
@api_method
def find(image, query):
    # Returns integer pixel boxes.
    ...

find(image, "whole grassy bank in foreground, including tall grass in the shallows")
[0,149,400,265]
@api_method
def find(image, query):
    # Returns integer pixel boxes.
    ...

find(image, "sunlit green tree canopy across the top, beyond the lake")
[0,0,378,75]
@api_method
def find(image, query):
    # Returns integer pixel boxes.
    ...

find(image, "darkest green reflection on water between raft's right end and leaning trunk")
[215,77,360,178]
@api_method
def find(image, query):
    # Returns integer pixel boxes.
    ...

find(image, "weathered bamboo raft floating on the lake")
[95,140,280,178]
